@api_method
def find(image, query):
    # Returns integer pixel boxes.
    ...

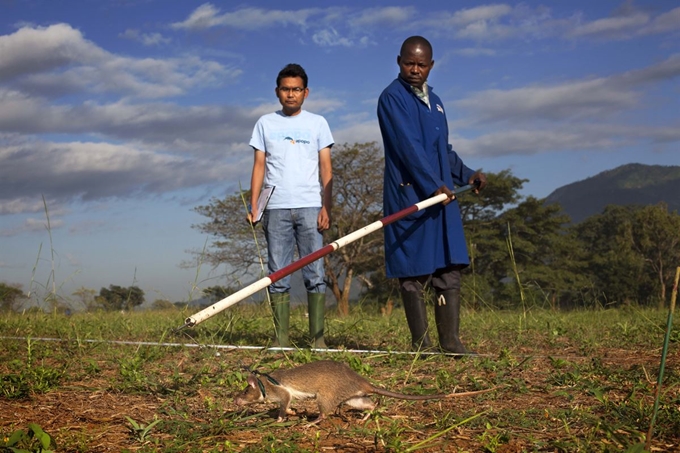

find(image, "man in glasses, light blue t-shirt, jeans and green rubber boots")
[248,64,334,348]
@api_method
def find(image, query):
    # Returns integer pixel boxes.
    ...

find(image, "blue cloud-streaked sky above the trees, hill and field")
[0,0,680,302]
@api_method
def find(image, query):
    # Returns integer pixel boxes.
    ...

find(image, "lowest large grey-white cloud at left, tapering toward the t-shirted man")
[0,141,238,213]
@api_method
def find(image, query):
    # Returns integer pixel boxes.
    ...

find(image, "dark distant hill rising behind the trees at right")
[546,164,680,223]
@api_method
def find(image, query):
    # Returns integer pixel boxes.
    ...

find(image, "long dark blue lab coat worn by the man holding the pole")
[378,77,474,278]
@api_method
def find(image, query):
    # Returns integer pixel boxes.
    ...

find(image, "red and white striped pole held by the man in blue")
[179,184,476,329]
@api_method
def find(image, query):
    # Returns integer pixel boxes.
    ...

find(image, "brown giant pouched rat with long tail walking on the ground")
[234,360,493,422]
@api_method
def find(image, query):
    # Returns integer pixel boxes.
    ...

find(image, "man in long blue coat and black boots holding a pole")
[378,36,486,354]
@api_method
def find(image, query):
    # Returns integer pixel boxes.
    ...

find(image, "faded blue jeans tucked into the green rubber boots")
[262,208,326,294]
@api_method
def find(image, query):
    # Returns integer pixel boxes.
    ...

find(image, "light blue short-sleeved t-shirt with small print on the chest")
[250,110,334,209]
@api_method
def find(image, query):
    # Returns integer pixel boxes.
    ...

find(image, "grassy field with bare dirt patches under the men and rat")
[0,305,680,453]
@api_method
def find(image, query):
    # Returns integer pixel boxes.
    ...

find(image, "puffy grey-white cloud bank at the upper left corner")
[0,24,241,98]
